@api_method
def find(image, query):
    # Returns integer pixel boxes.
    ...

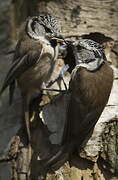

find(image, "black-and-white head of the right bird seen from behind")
[65,39,106,72]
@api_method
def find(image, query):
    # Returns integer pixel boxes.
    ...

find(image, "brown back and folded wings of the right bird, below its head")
[63,62,113,146]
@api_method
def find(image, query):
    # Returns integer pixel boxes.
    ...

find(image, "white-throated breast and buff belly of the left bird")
[18,45,55,94]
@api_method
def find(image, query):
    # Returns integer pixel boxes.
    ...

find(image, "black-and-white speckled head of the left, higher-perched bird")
[26,13,64,45]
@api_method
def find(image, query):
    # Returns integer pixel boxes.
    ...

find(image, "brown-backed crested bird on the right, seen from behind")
[45,39,113,169]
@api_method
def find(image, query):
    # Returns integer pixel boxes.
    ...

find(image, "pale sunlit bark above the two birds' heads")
[34,0,118,40]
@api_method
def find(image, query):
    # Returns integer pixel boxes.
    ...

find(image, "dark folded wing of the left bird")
[0,44,42,100]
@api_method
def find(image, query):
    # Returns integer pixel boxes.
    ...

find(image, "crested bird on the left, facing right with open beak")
[0,13,63,142]
